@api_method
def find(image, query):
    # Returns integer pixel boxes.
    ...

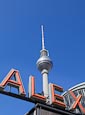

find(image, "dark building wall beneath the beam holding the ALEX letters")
[25,104,75,115]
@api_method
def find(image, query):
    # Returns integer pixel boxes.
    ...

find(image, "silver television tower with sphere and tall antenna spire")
[37,25,53,98]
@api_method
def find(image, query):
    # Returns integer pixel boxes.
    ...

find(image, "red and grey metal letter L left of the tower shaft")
[29,76,46,101]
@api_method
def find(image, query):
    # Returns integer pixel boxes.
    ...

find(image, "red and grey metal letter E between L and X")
[49,83,66,108]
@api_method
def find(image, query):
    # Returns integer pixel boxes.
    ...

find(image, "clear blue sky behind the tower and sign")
[0,0,85,115]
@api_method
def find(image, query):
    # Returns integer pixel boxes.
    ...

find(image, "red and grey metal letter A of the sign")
[0,69,26,96]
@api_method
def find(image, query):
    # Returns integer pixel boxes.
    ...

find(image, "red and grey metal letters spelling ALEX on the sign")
[0,69,85,114]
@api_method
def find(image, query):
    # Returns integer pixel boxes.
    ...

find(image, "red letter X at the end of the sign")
[69,90,85,114]
